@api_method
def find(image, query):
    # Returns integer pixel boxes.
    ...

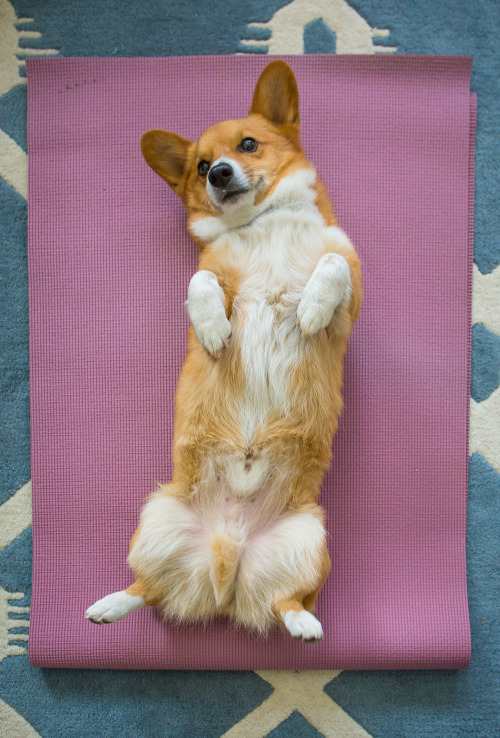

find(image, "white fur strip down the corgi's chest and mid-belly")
[205,204,329,497]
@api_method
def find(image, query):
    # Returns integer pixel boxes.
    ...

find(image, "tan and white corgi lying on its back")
[86,60,362,641]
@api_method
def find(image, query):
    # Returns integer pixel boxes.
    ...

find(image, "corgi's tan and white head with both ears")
[141,60,310,239]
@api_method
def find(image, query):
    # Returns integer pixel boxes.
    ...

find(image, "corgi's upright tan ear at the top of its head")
[250,59,300,128]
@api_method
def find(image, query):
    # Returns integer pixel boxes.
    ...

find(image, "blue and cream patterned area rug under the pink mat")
[0,0,500,738]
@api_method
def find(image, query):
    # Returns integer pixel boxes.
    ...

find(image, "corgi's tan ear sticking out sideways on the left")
[141,129,192,194]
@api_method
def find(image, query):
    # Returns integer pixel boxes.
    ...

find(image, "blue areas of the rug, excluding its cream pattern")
[0,0,500,738]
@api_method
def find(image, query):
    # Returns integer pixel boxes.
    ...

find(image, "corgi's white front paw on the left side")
[186,269,231,356]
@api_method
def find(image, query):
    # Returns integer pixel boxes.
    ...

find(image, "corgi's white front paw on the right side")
[297,254,351,336]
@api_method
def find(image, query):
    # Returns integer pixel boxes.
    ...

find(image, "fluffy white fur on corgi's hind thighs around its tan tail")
[128,492,326,637]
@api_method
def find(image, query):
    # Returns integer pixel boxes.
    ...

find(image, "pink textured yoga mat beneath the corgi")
[27,55,475,669]
